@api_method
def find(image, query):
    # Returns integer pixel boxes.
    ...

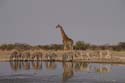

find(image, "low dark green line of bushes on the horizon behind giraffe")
[0,41,125,51]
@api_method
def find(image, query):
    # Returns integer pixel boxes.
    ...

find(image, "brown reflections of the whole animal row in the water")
[10,61,111,81]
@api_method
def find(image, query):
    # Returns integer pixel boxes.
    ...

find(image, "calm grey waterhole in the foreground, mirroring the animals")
[0,61,125,83]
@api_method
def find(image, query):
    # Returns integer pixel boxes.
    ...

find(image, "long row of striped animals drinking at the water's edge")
[10,50,111,61]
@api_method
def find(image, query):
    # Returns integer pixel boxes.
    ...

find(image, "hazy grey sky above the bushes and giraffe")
[0,0,125,44]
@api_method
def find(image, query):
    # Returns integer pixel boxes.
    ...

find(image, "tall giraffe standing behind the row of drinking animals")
[56,24,73,50]
